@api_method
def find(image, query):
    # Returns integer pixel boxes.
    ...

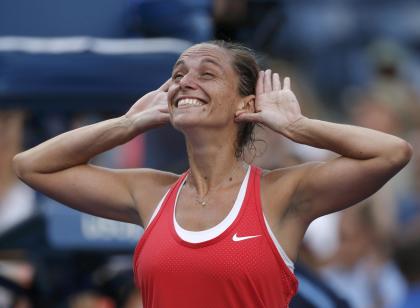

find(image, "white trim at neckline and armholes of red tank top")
[145,167,295,273]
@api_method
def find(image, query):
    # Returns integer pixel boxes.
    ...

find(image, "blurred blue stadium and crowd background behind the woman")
[0,0,420,308]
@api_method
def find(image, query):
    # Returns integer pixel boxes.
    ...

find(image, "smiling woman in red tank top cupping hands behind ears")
[14,41,412,307]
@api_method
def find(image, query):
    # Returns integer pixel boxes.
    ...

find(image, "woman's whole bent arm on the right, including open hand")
[237,71,412,224]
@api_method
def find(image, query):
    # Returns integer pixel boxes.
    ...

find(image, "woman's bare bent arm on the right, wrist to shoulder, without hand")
[284,117,412,222]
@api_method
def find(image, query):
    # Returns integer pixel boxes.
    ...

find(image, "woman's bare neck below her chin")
[186,128,245,196]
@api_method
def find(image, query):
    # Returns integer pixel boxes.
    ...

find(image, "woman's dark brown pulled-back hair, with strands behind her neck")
[206,40,259,158]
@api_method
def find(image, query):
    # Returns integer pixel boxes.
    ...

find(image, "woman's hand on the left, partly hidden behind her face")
[125,79,171,129]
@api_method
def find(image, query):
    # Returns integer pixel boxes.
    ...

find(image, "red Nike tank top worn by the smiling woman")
[133,166,297,308]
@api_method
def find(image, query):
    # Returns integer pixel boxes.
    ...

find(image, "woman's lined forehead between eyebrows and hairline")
[175,44,232,70]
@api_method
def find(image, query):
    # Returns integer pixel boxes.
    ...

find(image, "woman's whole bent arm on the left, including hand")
[13,81,173,225]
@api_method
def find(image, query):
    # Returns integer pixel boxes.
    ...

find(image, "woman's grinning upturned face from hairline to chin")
[168,44,244,130]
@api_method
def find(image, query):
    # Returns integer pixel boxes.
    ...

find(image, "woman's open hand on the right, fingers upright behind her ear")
[235,70,303,134]
